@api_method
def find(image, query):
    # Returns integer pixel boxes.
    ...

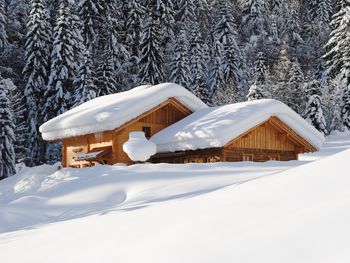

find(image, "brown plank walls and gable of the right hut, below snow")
[151,117,316,163]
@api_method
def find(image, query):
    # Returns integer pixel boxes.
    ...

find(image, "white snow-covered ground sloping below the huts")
[0,135,350,263]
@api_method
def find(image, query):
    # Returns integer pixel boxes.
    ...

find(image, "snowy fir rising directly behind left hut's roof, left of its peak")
[139,10,164,84]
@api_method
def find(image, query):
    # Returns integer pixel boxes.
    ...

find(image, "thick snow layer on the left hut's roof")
[40,83,208,140]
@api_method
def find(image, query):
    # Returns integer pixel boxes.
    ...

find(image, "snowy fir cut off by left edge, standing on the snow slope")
[0,77,16,180]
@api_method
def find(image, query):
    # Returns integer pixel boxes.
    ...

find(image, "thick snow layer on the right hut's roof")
[151,99,324,152]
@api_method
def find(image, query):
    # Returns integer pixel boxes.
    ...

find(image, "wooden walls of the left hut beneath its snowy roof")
[61,98,192,168]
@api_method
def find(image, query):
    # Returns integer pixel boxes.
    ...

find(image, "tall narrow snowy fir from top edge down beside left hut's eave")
[23,0,51,165]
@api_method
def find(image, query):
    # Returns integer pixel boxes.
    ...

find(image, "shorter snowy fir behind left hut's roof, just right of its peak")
[170,30,190,88]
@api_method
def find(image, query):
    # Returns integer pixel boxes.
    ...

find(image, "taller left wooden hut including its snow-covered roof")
[40,83,208,168]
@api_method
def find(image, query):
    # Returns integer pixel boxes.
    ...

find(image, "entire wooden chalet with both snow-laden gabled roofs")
[40,83,324,167]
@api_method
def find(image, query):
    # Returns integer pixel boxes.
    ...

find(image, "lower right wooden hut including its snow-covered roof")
[151,99,324,163]
